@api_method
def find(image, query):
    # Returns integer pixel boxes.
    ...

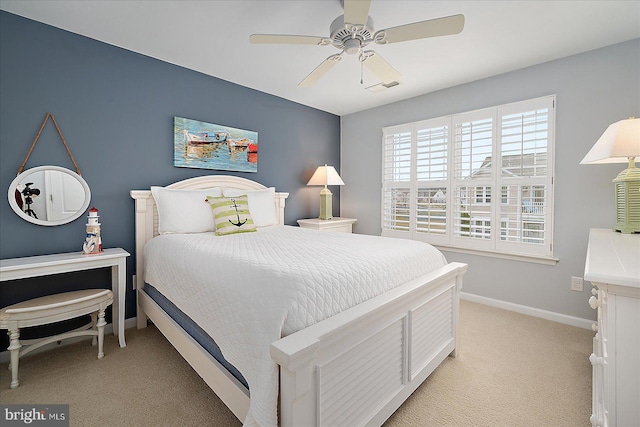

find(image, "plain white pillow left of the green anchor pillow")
[151,187,222,234]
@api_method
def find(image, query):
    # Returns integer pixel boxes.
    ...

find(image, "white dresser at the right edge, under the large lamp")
[584,229,640,427]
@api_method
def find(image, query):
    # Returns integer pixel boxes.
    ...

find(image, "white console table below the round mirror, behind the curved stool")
[0,248,129,347]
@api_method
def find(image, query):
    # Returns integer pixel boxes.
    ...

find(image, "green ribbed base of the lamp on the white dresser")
[613,159,640,234]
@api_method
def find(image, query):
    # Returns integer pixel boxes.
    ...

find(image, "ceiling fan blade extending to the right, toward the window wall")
[373,15,464,44]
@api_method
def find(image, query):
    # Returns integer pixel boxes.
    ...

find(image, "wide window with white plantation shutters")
[382,96,555,258]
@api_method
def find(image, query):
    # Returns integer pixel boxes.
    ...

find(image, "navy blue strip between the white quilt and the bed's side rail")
[144,283,249,389]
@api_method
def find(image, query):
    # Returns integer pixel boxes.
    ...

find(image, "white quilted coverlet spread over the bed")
[144,226,446,426]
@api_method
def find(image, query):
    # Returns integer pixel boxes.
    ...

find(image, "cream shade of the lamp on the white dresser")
[580,118,640,165]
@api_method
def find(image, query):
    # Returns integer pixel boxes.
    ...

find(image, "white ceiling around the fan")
[0,0,640,115]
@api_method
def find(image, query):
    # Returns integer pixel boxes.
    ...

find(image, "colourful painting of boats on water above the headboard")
[173,117,258,172]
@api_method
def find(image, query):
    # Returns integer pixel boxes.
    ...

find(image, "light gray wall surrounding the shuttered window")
[341,39,640,319]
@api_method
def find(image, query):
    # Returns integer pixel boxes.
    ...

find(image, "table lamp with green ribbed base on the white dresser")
[580,117,640,233]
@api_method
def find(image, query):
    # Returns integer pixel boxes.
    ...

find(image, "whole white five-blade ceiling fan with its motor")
[249,0,464,87]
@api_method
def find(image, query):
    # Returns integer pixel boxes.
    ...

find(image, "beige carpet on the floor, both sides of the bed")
[0,301,593,427]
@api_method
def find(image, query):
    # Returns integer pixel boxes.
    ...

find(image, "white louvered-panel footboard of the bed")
[271,263,467,426]
